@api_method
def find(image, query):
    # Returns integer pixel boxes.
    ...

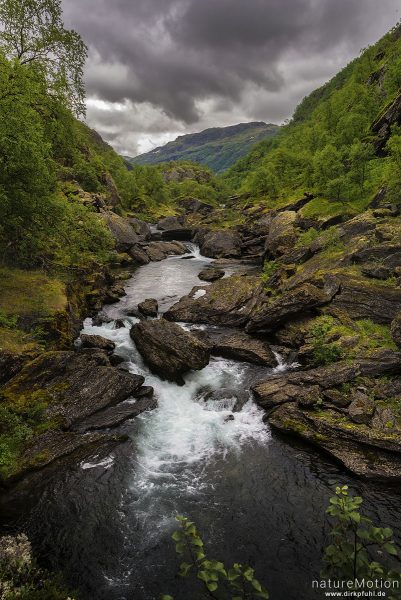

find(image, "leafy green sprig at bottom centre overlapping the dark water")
[161,516,269,600]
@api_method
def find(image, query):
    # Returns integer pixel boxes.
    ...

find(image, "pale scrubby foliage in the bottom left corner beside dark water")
[0,534,73,600]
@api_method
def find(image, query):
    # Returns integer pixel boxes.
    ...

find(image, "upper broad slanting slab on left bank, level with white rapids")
[2,349,144,428]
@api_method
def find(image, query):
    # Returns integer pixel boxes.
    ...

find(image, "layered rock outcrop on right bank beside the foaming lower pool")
[253,350,401,479]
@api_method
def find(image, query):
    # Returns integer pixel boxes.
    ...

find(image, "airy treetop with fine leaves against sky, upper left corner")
[0,0,87,115]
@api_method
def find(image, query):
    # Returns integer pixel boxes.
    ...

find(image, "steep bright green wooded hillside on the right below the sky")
[224,26,401,214]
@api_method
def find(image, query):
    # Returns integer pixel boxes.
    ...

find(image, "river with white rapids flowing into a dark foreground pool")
[9,246,401,600]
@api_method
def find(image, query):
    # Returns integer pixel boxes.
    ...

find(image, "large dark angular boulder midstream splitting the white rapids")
[131,319,210,384]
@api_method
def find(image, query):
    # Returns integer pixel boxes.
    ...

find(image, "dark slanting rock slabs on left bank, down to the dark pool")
[0,350,152,484]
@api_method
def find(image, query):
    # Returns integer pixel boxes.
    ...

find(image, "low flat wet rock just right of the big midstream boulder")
[212,332,277,367]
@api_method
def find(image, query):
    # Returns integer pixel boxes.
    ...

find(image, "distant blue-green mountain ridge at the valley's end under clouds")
[124,122,279,173]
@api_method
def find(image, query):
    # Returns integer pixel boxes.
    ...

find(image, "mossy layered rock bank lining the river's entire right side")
[156,194,401,480]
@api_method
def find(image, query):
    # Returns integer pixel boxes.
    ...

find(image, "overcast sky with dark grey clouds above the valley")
[63,0,401,156]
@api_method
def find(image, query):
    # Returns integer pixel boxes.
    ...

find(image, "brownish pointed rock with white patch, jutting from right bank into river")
[164,275,264,327]
